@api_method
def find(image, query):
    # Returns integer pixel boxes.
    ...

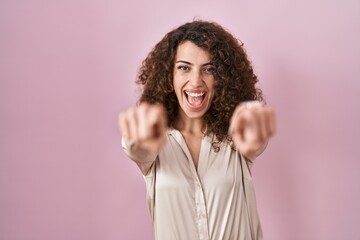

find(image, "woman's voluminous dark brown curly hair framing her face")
[136,20,263,151]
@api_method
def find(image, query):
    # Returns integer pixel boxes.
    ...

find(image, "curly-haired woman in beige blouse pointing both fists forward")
[119,21,275,240]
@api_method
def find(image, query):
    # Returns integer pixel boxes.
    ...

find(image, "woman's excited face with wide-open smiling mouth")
[173,41,215,122]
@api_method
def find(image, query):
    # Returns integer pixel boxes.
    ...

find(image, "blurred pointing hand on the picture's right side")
[229,101,276,159]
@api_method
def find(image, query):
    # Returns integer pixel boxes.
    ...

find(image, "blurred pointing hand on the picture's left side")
[119,103,167,154]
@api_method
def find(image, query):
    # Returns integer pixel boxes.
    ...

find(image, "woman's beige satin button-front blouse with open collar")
[122,129,262,240]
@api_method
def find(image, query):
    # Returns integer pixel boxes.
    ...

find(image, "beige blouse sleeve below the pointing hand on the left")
[121,137,156,176]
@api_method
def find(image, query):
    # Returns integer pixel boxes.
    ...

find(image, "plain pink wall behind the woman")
[0,0,360,240]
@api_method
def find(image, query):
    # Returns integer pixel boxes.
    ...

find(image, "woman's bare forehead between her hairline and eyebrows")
[175,41,211,63]
